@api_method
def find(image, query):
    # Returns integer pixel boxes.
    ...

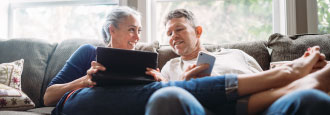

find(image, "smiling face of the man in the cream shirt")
[166,17,199,56]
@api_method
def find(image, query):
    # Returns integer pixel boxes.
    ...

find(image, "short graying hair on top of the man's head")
[164,9,196,27]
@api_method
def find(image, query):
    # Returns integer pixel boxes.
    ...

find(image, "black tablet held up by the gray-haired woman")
[92,47,158,85]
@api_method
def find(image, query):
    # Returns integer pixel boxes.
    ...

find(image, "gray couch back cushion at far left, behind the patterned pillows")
[0,39,57,107]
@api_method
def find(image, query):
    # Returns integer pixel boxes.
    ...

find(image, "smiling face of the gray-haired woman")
[110,15,141,50]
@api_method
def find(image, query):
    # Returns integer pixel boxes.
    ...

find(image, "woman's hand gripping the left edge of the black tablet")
[80,61,105,87]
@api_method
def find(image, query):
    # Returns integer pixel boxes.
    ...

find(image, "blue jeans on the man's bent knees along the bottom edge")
[146,87,330,115]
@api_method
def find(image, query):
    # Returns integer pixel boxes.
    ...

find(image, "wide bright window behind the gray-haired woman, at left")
[9,0,119,42]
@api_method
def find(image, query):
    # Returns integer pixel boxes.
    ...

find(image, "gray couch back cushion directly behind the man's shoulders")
[157,41,270,70]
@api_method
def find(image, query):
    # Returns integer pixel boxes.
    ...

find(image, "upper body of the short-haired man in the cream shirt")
[147,9,262,81]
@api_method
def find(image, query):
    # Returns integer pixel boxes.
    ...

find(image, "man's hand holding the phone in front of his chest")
[182,64,210,80]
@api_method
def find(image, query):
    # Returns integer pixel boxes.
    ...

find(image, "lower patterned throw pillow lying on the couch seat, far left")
[0,84,35,111]
